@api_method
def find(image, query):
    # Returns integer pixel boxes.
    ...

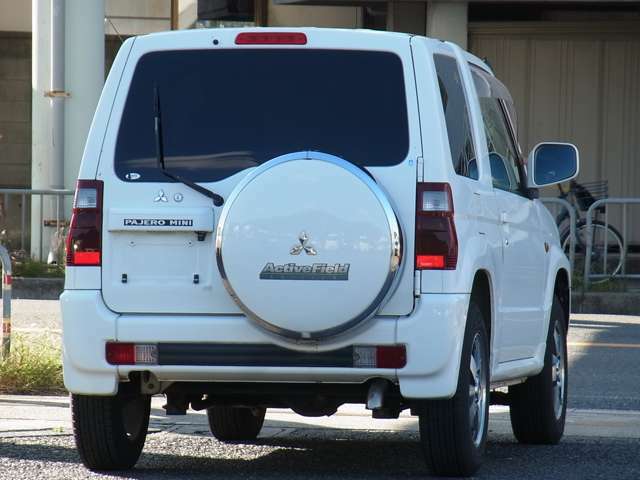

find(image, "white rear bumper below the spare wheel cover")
[60,290,469,398]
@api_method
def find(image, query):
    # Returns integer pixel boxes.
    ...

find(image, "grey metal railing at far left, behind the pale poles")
[0,188,74,260]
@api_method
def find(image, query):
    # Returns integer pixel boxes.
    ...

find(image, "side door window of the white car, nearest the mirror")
[471,67,523,193]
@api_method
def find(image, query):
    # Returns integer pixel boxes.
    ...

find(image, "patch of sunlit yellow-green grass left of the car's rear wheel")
[0,335,65,394]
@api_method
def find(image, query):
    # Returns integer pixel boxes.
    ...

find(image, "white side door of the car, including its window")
[471,67,546,362]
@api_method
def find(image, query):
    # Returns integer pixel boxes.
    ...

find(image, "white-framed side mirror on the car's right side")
[527,142,580,188]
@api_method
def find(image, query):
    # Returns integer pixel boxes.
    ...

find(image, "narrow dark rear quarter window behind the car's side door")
[433,55,478,180]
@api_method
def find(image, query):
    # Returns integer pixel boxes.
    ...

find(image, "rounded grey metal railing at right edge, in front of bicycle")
[583,197,640,289]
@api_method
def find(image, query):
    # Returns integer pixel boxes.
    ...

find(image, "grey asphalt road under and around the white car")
[0,301,640,480]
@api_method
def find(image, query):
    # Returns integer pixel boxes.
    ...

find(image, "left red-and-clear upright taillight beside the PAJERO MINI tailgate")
[66,180,102,267]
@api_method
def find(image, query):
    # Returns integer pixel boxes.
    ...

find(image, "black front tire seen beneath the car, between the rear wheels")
[207,406,266,442]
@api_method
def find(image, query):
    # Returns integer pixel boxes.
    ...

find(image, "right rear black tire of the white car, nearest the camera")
[419,298,490,477]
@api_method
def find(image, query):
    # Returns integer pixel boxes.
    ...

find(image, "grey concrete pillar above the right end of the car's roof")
[427,1,469,50]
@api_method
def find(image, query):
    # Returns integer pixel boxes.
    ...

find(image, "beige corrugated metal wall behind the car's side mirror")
[469,22,640,243]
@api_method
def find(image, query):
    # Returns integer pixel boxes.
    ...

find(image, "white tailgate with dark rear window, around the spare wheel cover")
[97,29,421,315]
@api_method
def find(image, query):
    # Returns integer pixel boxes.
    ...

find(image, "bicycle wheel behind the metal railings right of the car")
[561,220,625,284]
